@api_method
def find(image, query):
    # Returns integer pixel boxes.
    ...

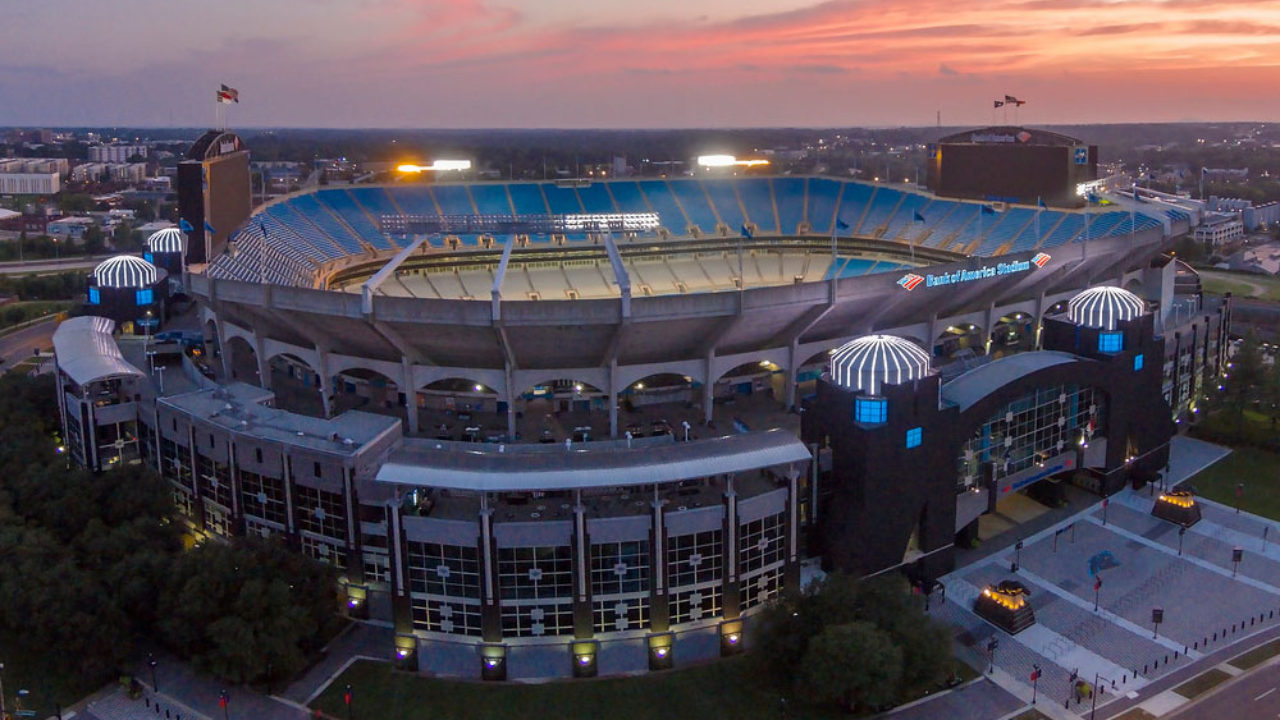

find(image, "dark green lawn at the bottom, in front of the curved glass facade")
[311,657,974,720]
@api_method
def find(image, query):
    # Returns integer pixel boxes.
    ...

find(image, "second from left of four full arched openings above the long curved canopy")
[516,378,613,443]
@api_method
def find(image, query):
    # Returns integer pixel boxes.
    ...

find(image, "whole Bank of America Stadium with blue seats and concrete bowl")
[55,128,1230,679]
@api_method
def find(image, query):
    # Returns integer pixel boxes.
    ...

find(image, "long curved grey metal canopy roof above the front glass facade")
[376,429,810,492]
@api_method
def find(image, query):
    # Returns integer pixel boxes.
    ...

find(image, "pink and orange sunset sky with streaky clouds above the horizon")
[0,0,1280,128]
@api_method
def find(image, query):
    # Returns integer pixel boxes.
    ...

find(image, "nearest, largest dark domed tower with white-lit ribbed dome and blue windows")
[801,334,955,577]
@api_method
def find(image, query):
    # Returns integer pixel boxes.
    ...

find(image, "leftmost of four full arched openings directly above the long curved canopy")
[415,378,508,442]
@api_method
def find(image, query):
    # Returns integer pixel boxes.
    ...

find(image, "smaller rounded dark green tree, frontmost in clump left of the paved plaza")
[800,621,902,710]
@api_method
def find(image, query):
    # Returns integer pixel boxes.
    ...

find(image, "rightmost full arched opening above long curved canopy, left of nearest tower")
[710,360,787,433]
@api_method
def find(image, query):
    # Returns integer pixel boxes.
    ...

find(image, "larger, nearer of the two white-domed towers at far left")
[86,255,169,334]
